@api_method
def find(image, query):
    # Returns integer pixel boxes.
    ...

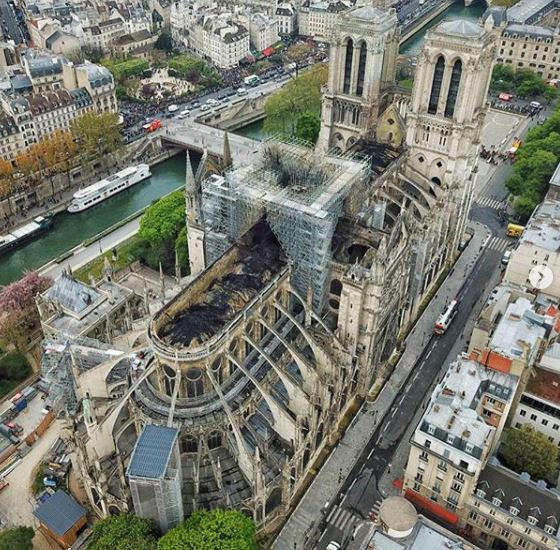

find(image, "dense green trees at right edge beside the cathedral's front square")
[506,104,560,220]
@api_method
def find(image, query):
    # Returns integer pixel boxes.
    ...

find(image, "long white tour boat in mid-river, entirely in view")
[68,164,152,213]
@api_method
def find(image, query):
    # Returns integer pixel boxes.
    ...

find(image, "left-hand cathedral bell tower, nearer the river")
[317,5,399,151]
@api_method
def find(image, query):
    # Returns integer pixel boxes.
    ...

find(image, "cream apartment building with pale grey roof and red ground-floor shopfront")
[404,356,519,524]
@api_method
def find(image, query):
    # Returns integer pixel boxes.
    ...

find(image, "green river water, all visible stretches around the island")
[0,0,485,285]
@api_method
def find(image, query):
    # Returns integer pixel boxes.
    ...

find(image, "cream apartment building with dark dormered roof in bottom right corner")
[466,464,560,550]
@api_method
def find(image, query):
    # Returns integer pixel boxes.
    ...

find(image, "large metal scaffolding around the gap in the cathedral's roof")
[202,139,369,311]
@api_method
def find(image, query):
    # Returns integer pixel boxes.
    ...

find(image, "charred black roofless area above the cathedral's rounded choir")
[158,221,287,347]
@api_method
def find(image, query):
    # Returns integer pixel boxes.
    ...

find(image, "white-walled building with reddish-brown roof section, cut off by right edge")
[511,343,560,446]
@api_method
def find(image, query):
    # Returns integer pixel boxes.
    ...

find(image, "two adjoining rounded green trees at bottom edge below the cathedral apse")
[88,509,258,550]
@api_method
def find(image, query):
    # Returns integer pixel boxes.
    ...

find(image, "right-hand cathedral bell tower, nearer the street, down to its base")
[402,21,495,308]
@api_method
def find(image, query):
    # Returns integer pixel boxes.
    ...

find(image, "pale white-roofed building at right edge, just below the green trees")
[504,199,560,298]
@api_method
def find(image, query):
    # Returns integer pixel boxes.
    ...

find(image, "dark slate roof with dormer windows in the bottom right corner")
[476,458,560,534]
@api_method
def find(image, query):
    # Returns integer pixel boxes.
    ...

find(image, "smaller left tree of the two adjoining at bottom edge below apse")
[88,514,156,550]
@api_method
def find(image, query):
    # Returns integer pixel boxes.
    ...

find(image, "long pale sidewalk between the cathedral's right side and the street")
[272,223,490,550]
